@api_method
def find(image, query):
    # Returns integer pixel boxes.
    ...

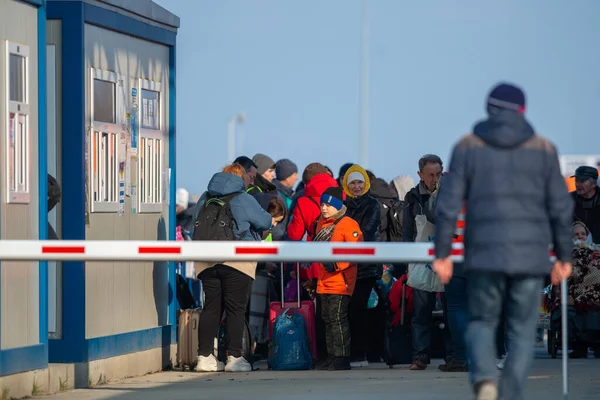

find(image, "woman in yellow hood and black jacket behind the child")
[342,165,383,368]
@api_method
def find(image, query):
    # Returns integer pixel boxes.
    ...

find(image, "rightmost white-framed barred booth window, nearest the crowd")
[138,80,164,213]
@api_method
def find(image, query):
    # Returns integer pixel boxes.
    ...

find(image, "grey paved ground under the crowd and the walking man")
[44,358,600,400]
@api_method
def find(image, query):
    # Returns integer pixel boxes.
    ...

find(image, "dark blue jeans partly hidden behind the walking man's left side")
[445,276,469,363]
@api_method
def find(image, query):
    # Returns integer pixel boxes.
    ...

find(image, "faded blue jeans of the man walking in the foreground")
[466,271,544,400]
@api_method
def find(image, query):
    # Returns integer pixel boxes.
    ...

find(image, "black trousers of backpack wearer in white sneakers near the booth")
[198,264,252,361]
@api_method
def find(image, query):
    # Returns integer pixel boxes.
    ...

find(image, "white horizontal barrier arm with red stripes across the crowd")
[0,240,553,263]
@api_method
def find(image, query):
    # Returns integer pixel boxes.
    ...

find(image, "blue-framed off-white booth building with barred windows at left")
[0,0,179,394]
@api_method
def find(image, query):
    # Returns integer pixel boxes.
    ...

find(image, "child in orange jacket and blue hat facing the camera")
[313,187,363,371]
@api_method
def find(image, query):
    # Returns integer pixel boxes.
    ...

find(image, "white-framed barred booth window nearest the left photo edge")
[5,42,30,204]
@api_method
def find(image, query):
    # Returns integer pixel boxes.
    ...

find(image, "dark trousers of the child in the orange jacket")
[320,294,352,357]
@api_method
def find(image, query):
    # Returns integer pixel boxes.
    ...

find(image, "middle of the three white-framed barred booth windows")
[90,69,124,212]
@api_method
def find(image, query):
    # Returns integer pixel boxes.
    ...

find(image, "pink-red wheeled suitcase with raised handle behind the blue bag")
[269,263,317,360]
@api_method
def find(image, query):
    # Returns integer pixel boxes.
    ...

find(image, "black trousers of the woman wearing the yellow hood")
[350,278,377,361]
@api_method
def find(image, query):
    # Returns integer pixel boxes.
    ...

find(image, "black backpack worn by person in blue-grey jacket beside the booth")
[192,193,240,240]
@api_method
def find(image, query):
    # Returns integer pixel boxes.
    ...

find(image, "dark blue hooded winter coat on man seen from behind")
[435,110,573,276]
